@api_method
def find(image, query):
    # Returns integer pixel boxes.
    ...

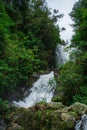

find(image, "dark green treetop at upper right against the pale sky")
[70,0,87,51]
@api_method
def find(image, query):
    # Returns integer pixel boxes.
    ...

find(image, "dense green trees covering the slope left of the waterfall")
[0,0,62,97]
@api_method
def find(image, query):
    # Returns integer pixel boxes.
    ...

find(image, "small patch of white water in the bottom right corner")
[75,114,87,130]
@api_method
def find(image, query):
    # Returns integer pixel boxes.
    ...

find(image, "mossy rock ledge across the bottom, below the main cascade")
[1,102,87,130]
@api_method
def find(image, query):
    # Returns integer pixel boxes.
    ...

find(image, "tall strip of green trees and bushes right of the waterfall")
[59,0,87,105]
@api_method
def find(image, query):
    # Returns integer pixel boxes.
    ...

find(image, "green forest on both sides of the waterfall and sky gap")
[0,0,87,111]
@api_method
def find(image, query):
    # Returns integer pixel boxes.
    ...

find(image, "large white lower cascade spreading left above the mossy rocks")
[13,71,56,108]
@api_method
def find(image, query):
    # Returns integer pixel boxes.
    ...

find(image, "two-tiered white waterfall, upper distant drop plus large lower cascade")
[13,45,68,108]
